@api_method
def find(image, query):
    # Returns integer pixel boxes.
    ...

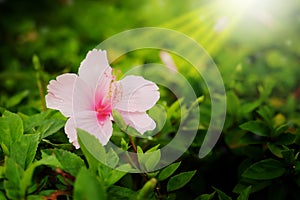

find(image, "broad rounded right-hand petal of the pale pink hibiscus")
[114,76,159,112]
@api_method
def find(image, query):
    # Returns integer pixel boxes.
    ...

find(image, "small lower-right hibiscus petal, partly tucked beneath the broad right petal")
[119,111,156,134]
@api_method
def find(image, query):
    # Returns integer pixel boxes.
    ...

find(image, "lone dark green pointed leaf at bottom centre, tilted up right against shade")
[167,170,196,192]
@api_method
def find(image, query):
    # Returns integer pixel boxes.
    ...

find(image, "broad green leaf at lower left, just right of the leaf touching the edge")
[10,134,39,169]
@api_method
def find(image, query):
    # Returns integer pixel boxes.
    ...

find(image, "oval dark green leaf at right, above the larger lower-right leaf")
[240,121,271,137]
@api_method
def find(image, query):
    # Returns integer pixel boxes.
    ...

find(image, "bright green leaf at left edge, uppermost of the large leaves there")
[0,111,24,155]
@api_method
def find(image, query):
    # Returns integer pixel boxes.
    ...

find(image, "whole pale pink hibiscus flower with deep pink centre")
[46,49,160,148]
